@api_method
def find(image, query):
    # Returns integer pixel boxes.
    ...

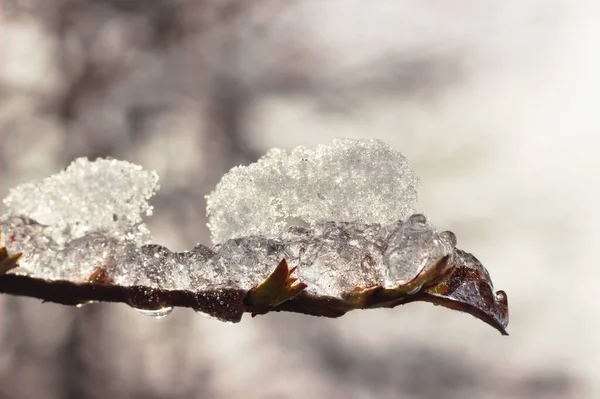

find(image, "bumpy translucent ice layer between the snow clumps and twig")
[0,215,454,297]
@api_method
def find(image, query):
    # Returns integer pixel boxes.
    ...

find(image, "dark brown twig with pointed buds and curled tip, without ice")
[0,244,508,335]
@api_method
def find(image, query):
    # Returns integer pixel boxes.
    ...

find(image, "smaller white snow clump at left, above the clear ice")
[4,158,158,243]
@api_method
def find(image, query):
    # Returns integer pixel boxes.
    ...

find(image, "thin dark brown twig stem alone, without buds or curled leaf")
[0,262,508,335]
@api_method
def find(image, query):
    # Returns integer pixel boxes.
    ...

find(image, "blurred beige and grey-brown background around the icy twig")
[0,0,600,399]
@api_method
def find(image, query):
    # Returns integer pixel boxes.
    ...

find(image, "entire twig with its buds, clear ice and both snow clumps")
[0,140,508,334]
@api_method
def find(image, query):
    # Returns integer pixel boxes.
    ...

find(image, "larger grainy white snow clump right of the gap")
[207,139,419,243]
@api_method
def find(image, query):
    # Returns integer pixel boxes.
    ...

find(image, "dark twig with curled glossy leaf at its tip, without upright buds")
[0,253,508,335]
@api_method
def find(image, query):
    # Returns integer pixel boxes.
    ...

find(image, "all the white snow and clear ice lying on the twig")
[0,140,456,300]
